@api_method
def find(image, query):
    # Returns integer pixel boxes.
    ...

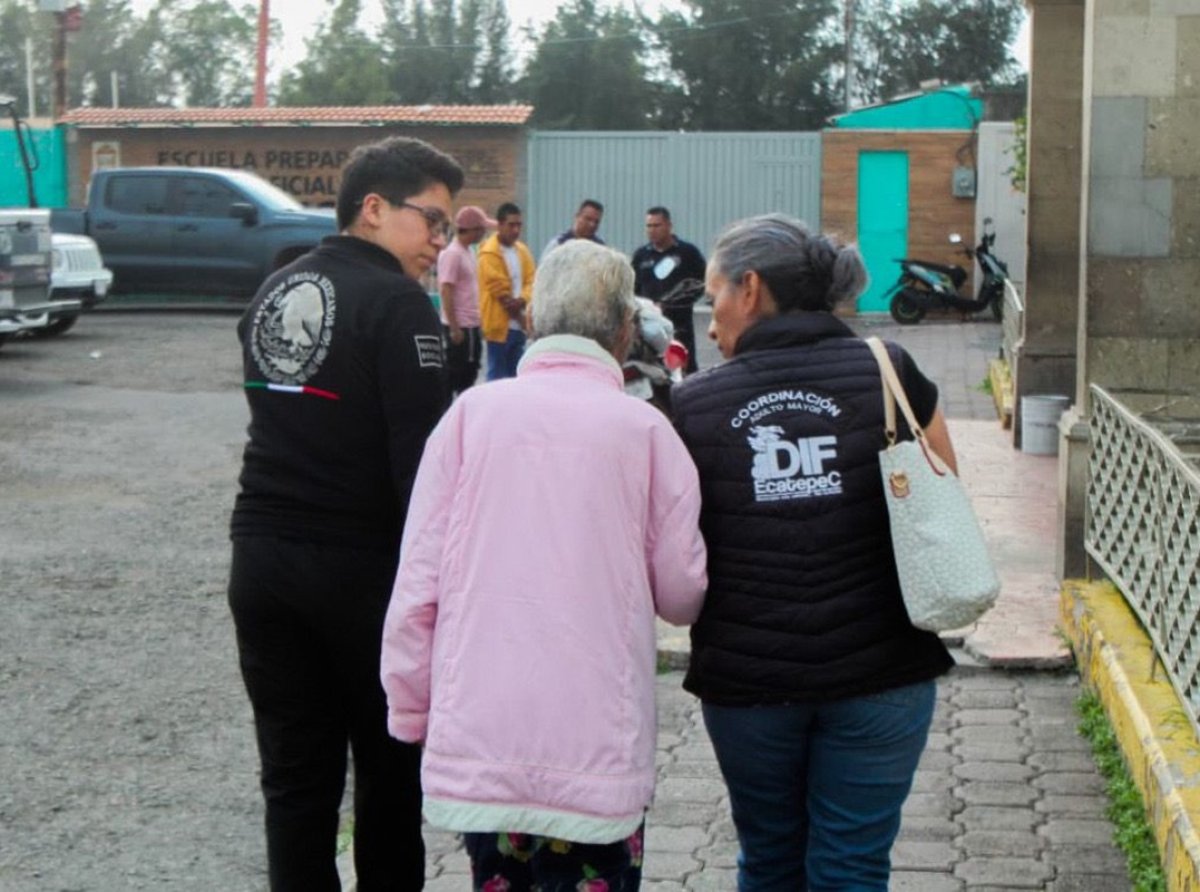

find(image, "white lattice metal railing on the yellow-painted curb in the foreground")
[1084,384,1200,728]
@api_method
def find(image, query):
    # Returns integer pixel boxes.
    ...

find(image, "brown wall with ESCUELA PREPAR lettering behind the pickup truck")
[58,125,526,217]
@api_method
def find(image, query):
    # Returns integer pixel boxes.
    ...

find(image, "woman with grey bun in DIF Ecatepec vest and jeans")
[672,215,955,892]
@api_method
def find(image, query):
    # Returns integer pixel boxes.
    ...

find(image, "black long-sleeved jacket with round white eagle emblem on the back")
[232,235,446,550]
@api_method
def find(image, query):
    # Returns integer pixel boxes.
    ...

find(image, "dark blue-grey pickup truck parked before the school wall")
[50,167,336,294]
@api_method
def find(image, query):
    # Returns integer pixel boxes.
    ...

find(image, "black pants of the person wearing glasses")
[229,537,425,892]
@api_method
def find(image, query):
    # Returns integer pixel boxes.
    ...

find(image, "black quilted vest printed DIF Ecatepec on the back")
[672,313,953,706]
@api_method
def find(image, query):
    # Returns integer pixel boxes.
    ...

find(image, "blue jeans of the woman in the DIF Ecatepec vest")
[703,682,937,892]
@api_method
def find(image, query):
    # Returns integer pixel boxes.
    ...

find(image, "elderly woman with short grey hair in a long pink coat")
[382,240,707,892]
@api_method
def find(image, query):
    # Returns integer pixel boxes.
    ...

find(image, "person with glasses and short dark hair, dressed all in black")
[229,137,463,892]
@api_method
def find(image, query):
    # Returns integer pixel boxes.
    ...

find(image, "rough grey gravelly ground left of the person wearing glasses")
[0,313,265,892]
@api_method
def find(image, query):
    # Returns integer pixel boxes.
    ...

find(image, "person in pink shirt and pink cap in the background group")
[438,204,496,396]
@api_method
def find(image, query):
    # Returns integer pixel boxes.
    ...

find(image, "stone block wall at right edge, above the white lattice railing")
[1080,0,1200,418]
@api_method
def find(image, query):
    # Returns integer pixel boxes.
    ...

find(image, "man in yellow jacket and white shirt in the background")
[479,202,534,381]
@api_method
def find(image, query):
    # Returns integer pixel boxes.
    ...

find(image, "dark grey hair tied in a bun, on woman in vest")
[712,214,866,313]
